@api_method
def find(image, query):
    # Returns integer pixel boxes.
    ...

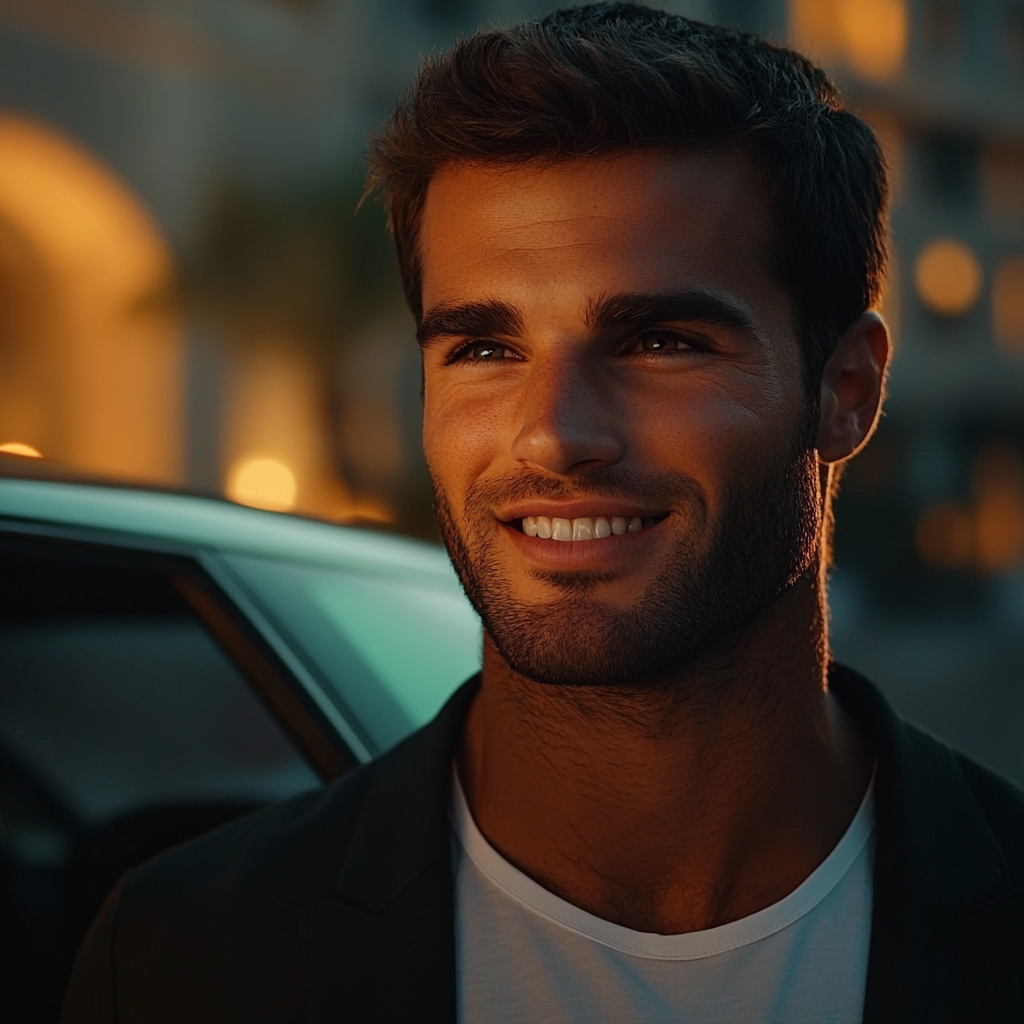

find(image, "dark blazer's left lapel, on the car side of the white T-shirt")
[302,678,479,1024]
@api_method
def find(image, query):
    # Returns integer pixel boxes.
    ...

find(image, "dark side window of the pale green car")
[0,534,319,1022]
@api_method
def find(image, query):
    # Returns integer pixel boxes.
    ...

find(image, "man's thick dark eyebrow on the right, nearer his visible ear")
[585,290,762,338]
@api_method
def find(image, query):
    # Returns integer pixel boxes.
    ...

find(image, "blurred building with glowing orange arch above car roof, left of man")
[0,0,552,530]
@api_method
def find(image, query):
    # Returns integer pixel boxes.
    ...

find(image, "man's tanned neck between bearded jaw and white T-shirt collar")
[459,572,871,934]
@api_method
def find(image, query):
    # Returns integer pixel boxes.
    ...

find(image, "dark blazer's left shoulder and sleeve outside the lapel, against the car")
[63,766,373,1024]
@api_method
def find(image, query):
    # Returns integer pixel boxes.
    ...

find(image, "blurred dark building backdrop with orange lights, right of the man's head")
[774,0,1024,781]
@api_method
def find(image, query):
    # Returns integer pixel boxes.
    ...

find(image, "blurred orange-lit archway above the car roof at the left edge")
[0,114,182,482]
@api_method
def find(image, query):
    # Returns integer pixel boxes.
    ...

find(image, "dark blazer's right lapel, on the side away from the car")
[829,666,1007,1024]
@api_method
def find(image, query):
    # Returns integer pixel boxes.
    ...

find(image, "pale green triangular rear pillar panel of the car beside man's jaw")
[223,554,481,752]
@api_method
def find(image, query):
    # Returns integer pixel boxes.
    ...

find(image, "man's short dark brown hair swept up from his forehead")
[367,3,888,390]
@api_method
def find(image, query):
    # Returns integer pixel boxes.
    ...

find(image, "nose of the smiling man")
[512,360,625,475]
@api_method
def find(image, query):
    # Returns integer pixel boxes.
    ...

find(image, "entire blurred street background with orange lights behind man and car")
[0,0,1024,781]
